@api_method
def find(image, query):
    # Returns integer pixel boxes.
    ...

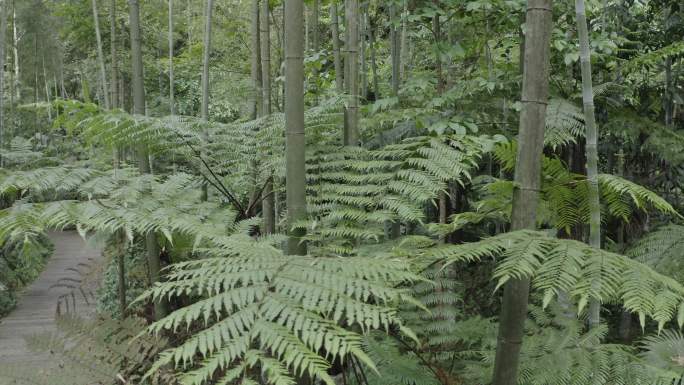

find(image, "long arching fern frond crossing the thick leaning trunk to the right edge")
[425,231,684,329]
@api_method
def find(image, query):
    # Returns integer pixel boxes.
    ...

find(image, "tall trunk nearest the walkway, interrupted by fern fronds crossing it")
[128,0,167,320]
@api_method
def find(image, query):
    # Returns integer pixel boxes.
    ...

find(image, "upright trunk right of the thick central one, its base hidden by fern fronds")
[344,0,360,146]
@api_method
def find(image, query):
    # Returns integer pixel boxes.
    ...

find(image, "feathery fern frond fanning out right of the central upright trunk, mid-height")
[307,135,497,254]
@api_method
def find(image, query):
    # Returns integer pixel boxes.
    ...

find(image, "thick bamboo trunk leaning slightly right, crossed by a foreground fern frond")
[492,0,553,385]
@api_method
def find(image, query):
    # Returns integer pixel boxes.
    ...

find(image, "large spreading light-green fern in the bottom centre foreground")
[141,246,418,385]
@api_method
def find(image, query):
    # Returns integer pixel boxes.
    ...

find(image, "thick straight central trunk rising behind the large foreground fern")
[285,0,307,255]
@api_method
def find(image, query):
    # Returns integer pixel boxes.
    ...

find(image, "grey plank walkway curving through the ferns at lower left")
[0,231,101,367]
